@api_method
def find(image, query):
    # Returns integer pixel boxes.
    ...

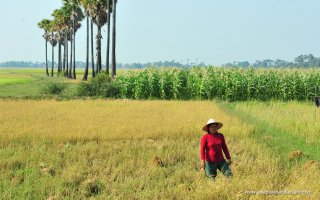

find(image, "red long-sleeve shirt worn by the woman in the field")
[200,133,231,162]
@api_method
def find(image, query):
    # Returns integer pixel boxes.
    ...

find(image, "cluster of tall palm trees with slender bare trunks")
[38,0,117,80]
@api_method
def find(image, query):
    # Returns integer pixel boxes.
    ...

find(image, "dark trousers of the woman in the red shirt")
[206,160,232,179]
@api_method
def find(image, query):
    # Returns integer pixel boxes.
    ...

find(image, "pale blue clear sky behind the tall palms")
[0,0,320,65]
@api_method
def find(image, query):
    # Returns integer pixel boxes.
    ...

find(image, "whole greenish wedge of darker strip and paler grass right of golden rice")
[219,102,320,166]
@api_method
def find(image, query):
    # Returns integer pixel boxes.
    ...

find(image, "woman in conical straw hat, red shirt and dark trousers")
[200,119,232,179]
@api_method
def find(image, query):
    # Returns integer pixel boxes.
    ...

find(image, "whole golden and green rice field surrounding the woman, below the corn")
[0,99,320,199]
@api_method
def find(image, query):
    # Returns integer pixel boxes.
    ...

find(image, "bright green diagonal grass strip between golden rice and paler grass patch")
[218,102,320,167]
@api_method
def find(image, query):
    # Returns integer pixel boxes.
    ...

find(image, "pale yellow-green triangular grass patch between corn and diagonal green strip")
[225,101,320,145]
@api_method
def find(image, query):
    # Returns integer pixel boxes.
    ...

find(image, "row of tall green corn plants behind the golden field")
[114,67,320,101]
